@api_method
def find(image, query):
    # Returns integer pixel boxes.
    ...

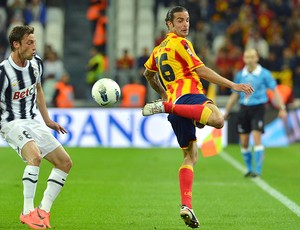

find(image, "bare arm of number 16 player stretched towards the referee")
[196,66,254,95]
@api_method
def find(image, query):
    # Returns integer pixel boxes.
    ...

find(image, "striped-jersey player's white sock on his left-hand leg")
[22,165,40,215]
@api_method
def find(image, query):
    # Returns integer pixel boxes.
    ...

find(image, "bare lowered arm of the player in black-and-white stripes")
[36,83,67,134]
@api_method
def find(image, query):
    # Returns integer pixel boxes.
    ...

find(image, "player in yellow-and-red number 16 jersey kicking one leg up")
[143,6,253,228]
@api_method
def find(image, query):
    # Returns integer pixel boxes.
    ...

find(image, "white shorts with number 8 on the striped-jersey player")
[0,119,61,160]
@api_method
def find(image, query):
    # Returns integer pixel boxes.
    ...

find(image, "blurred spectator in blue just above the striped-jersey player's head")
[24,0,46,27]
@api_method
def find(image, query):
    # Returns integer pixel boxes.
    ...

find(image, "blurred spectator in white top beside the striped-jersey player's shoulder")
[44,49,64,81]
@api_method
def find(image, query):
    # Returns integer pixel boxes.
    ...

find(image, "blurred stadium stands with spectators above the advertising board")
[0,0,300,146]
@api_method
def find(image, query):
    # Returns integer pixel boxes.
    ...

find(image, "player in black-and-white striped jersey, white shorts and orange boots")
[0,26,72,229]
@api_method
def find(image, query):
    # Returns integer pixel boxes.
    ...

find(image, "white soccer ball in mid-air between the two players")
[92,78,121,106]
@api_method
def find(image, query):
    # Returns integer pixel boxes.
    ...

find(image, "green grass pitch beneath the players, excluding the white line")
[0,144,300,230]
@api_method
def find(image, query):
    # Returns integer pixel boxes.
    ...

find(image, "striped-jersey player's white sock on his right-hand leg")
[39,168,68,212]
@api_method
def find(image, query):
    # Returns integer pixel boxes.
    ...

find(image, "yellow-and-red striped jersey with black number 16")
[145,33,204,102]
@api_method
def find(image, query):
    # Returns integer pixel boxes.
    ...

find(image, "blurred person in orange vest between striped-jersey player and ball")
[53,73,74,108]
